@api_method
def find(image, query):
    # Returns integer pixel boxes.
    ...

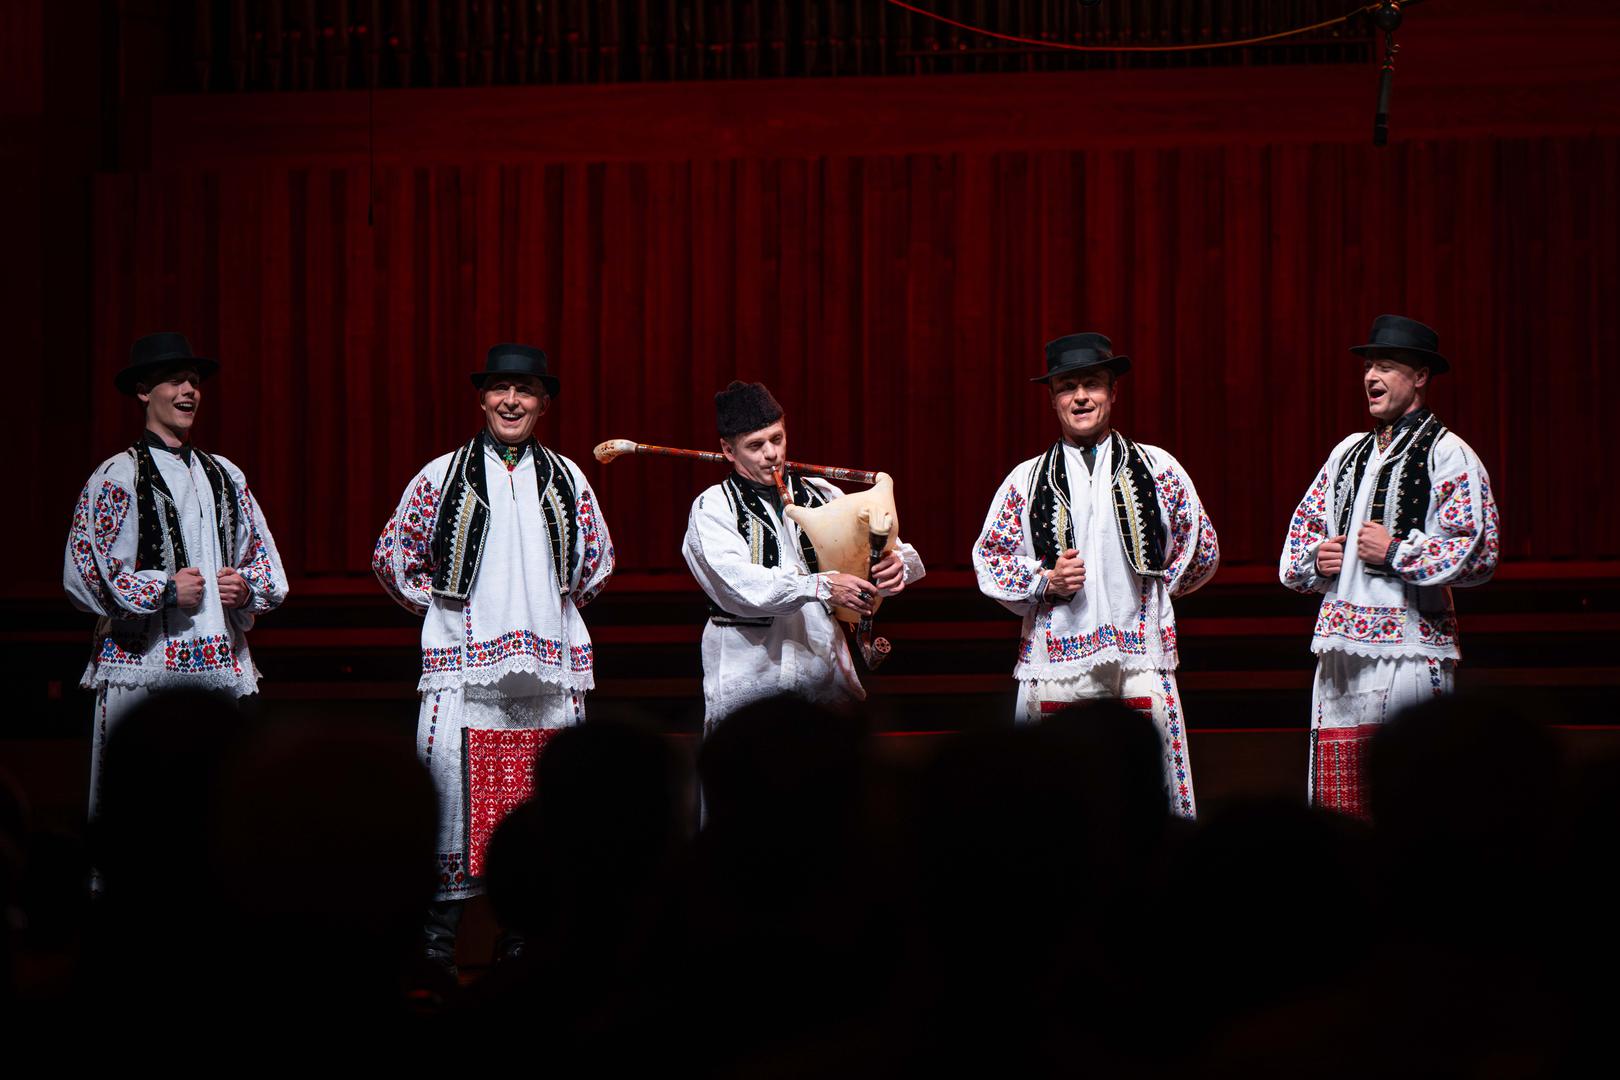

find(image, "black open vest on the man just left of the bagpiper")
[431,432,580,601]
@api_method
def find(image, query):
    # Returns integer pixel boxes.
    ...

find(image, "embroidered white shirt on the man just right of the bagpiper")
[972,439,1220,682]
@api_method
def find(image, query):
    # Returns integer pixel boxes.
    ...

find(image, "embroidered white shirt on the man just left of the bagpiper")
[371,440,614,691]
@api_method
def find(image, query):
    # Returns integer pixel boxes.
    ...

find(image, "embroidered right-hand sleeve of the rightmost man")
[1390,436,1502,588]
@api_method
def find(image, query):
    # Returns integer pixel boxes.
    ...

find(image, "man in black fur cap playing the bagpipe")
[682,381,923,732]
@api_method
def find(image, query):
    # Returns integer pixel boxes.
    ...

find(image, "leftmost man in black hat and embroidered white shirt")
[62,334,287,835]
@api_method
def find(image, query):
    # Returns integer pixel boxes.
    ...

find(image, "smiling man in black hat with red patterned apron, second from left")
[371,345,614,967]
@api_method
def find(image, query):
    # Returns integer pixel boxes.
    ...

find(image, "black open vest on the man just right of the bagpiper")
[1029,431,1166,578]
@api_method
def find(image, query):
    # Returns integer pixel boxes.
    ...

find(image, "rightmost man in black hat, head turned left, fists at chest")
[1278,316,1500,814]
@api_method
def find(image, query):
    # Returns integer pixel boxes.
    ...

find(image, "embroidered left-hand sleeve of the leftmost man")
[62,463,168,619]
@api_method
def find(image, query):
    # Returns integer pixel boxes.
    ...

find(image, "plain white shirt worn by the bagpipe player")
[680,479,925,725]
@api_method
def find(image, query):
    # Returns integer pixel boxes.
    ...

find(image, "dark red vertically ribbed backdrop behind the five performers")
[78,138,1620,576]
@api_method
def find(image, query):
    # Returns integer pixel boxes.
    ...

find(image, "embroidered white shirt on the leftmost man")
[62,449,288,696]
